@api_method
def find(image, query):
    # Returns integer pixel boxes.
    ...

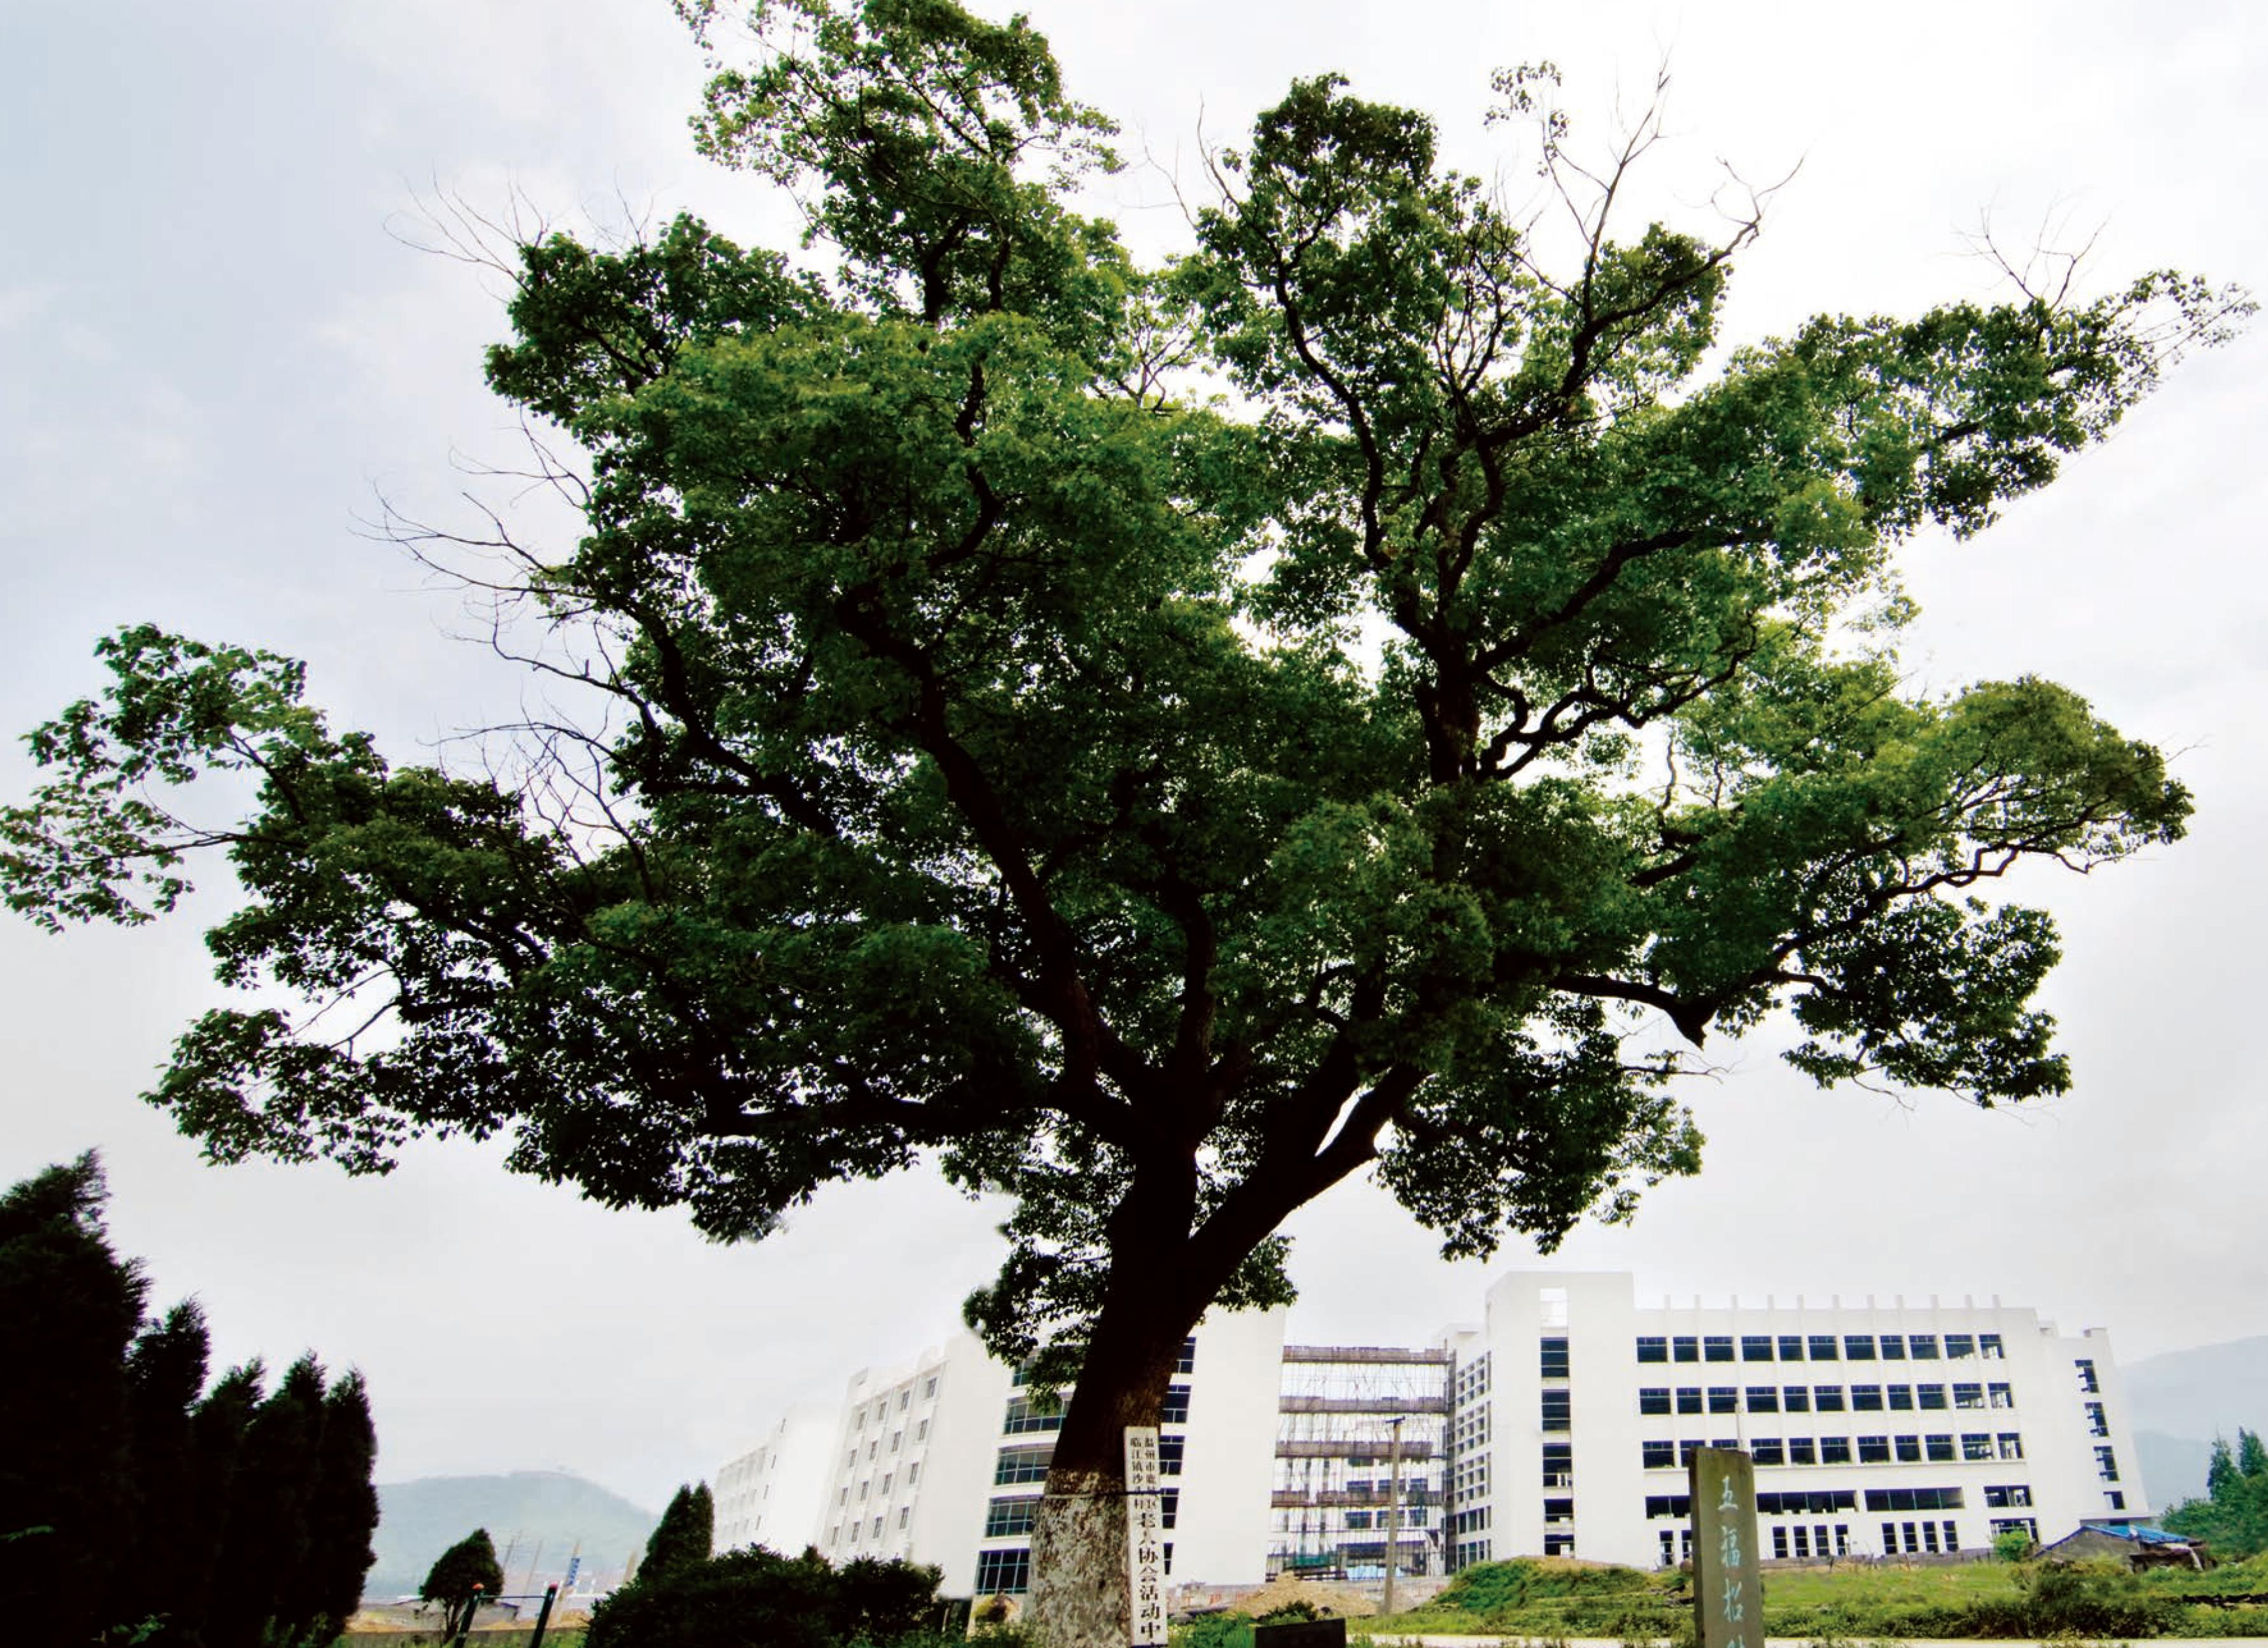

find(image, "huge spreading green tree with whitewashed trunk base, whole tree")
[4,0,2246,1648]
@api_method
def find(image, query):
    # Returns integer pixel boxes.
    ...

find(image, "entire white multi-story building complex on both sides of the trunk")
[717,1272,2148,1596]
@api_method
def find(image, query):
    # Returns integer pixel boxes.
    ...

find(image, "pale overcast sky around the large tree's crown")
[0,0,2268,1505]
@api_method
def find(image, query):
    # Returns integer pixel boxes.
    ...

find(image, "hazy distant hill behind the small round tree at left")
[363,1471,660,1598]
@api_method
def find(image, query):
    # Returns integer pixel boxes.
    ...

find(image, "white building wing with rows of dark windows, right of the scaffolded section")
[1449,1272,2150,1566]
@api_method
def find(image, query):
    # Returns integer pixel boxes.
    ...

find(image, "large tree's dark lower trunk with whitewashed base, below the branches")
[1027,1254,1204,1648]
